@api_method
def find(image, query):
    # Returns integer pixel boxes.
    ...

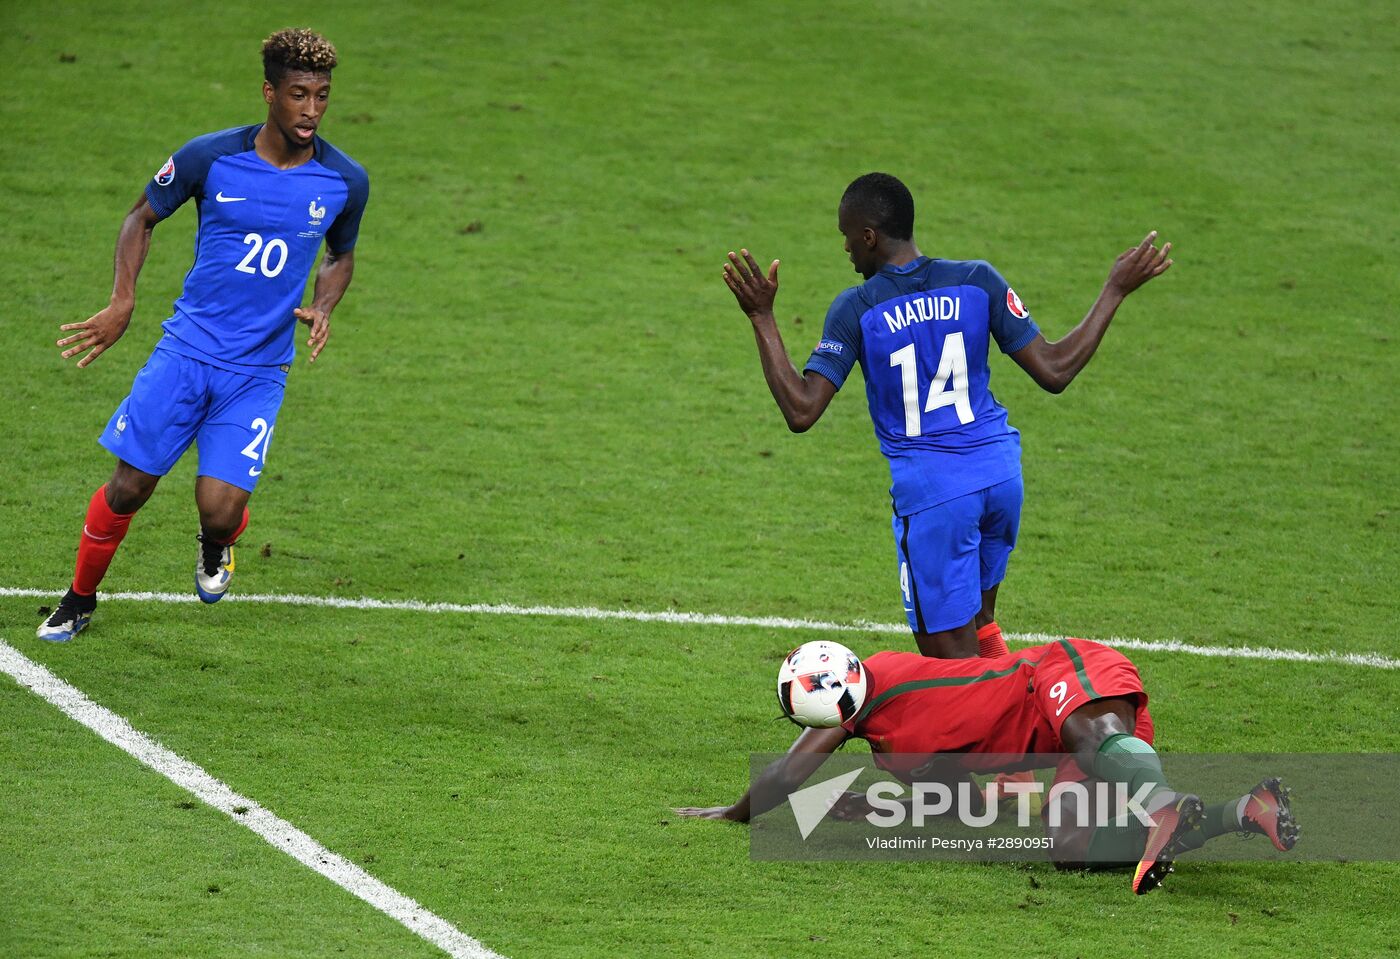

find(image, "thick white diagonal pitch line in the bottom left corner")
[0,640,501,959]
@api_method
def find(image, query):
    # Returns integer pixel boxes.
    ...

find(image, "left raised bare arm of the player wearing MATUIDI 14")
[724,249,836,433]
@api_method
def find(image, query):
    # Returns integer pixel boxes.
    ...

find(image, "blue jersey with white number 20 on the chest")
[146,125,370,381]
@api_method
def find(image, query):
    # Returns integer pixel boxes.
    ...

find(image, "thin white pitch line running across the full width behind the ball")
[0,587,1400,669]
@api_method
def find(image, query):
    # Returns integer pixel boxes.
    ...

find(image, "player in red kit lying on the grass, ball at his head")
[676,640,1298,895]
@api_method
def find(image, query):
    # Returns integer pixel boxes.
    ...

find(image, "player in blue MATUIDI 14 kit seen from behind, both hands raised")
[724,174,1172,658]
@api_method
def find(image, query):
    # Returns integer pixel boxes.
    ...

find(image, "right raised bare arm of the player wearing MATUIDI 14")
[1011,230,1172,393]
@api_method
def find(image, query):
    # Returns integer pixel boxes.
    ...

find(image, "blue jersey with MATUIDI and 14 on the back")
[806,256,1039,517]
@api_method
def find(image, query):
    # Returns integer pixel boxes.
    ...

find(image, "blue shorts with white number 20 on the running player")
[99,350,286,493]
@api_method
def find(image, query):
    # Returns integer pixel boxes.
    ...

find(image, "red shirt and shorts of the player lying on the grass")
[844,640,1152,771]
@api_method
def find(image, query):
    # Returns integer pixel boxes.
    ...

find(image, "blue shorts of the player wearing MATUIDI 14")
[893,476,1022,633]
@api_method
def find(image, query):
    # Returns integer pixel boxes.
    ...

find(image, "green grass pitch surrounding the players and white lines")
[0,3,1400,959]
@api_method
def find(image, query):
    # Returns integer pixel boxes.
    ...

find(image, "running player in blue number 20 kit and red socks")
[38,29,370,641]
